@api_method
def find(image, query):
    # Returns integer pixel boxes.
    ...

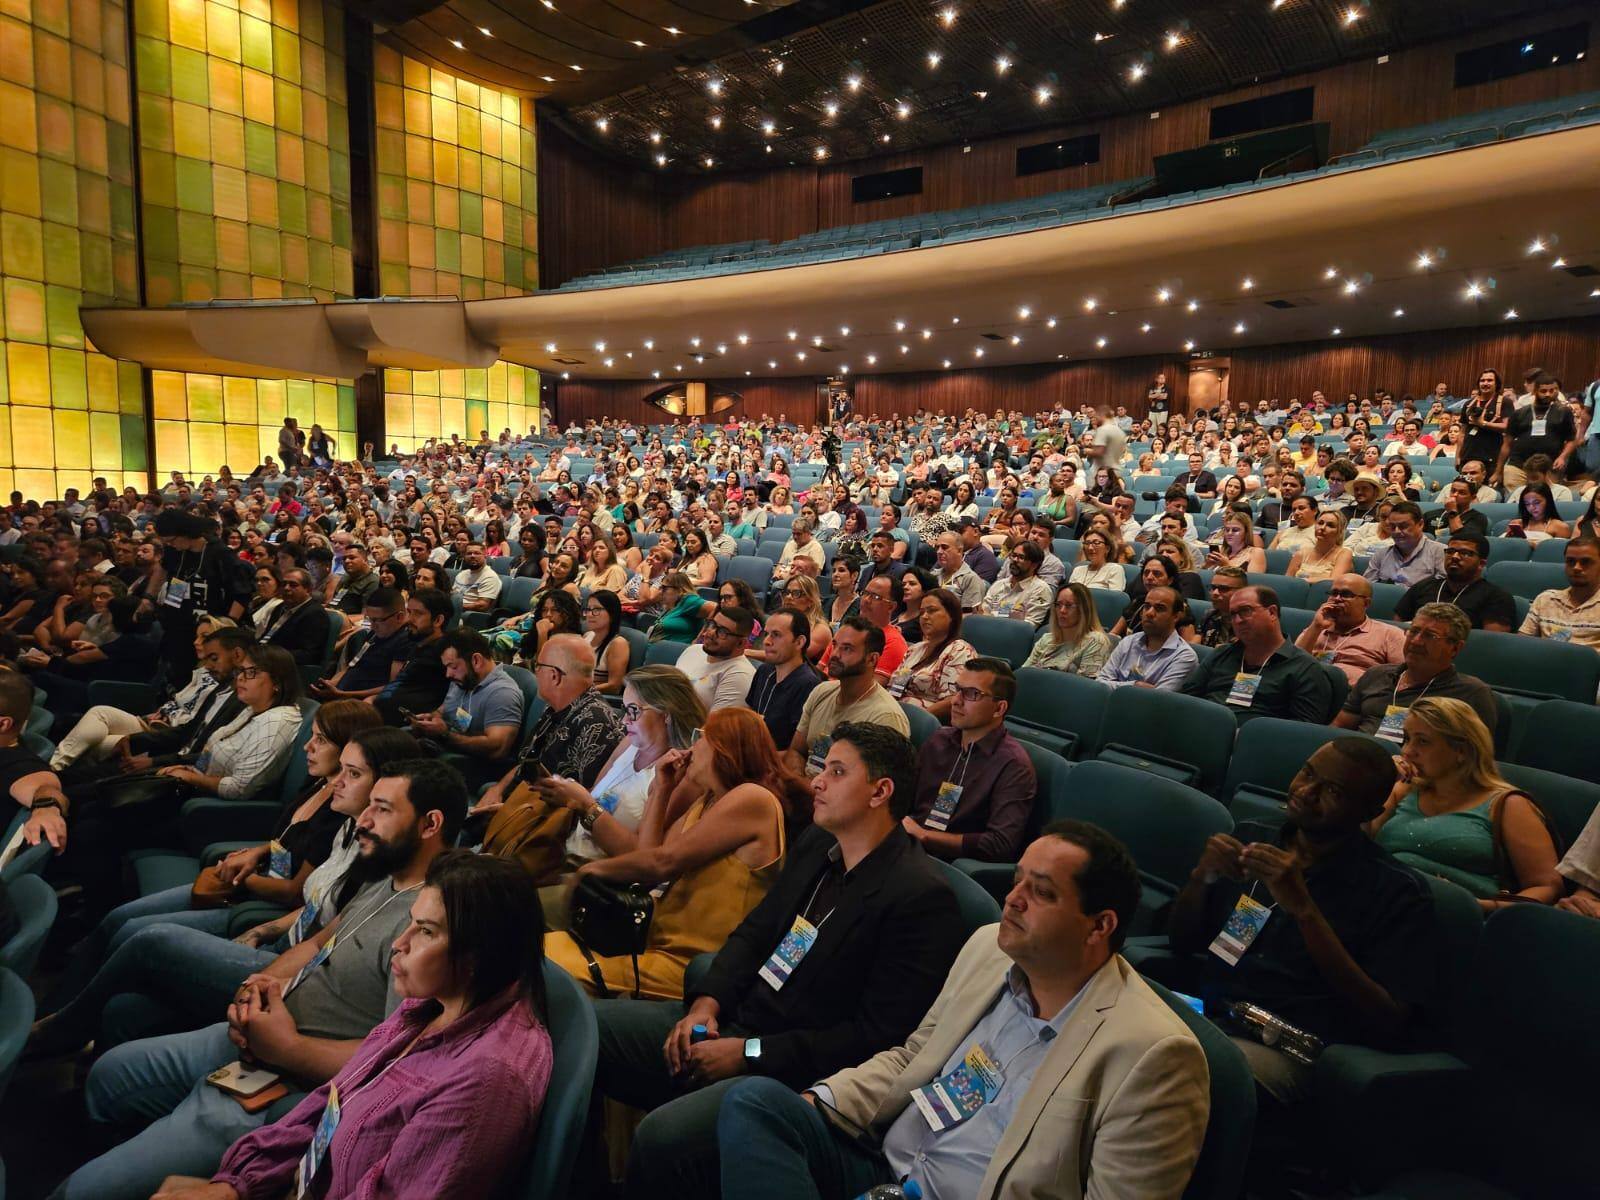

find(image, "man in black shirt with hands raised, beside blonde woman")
[1168,738,1437,1106]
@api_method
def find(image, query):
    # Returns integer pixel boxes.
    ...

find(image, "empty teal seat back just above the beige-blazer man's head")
[1067,762,1234,891]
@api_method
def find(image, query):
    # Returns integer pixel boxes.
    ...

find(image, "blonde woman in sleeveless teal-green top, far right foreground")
[1368,696,1565,909]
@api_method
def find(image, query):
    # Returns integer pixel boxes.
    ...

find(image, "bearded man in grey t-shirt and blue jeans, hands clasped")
[58,758,467,1200]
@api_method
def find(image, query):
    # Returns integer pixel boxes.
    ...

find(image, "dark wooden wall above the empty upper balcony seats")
[539,8,1600,288]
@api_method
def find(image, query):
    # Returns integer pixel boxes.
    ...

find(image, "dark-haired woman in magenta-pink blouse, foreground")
[157,850,554,1200]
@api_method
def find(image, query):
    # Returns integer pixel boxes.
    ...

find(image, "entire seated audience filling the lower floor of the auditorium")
[0,371,1600,1200]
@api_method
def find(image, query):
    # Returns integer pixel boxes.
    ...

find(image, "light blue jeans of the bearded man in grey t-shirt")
[54,1024,266,1200]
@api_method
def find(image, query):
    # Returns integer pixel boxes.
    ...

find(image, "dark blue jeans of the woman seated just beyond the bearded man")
[48,912,277,1050]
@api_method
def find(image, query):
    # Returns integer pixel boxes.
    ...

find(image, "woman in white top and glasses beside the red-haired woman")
[524,664,706,928]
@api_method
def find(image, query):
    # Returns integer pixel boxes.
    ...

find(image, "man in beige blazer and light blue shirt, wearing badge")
[717,821,1210,1200]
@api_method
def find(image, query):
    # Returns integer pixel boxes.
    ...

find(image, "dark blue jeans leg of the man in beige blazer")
[717,1078,893,1200]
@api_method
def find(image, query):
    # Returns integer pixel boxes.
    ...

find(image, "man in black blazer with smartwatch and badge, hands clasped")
[595,723,968,1200]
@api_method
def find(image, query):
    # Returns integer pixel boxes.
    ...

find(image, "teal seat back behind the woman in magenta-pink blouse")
[506,960,600,1200]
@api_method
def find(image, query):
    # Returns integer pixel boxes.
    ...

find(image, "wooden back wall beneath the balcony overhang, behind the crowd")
[555,317,1600,426]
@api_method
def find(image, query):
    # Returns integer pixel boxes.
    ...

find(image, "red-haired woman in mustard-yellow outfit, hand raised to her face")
[544,709,811,1000]
